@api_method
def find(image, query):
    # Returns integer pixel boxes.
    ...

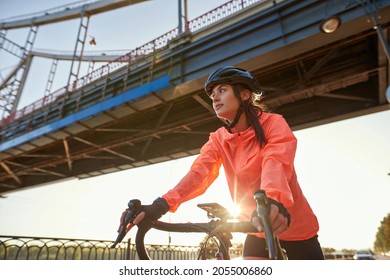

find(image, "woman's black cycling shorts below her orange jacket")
[243,234,324,260]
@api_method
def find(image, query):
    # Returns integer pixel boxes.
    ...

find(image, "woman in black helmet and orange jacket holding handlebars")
[122,66,324,260]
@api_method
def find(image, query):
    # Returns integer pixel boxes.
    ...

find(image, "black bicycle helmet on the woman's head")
[204,66,262,96]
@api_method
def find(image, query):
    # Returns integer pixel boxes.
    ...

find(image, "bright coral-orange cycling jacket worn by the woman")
[162,112,319,241]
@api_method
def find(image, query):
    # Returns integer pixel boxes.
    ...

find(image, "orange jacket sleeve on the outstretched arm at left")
[162,139,221,212]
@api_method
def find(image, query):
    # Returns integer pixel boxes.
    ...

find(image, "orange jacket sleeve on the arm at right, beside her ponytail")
[260,115,297,207]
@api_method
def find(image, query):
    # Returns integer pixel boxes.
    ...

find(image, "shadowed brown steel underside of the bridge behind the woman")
[0,1,390,194]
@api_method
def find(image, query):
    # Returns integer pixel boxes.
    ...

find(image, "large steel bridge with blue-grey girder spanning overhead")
[0,0,390,194]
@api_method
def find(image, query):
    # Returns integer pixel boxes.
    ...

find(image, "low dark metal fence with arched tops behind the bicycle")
[0,236,200,260]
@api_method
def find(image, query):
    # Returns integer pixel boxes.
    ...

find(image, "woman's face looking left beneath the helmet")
[210,84,240,122]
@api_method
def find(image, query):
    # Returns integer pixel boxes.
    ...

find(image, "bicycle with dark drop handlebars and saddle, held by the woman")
[111,190,287,260]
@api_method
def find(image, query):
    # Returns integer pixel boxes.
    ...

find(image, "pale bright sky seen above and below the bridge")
[0,0,390,252]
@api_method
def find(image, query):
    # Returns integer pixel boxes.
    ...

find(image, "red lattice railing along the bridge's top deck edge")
[0,0,272,126]
